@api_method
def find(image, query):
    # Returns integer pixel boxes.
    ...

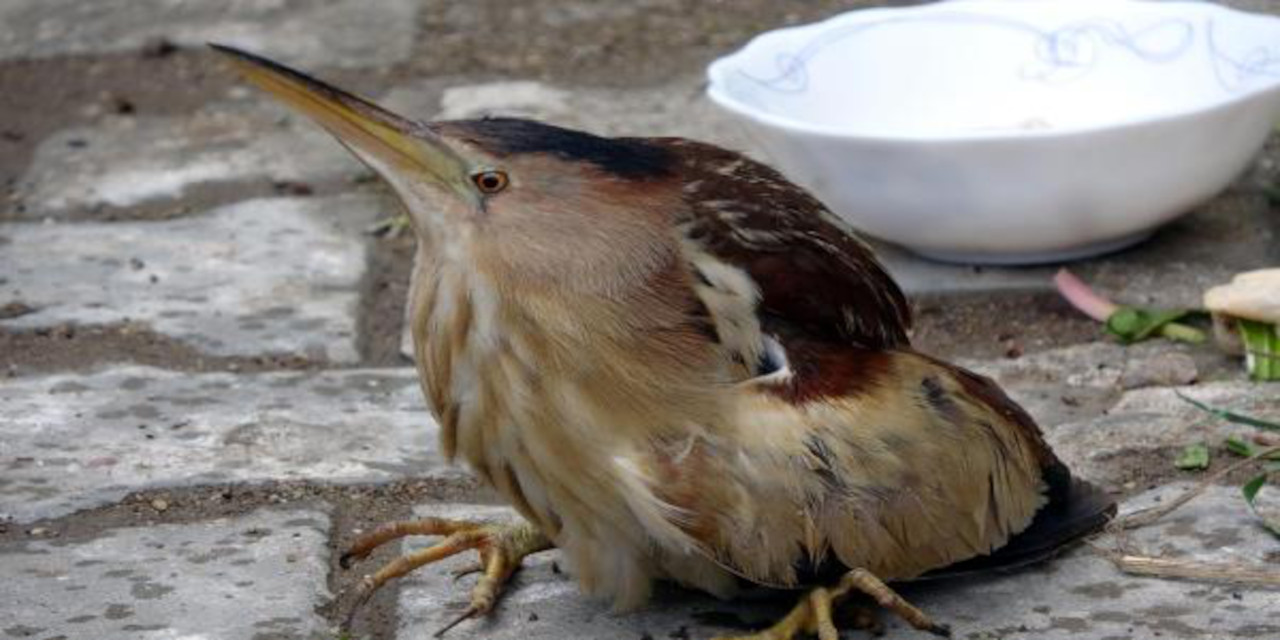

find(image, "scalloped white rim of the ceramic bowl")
[705,0,1280,143]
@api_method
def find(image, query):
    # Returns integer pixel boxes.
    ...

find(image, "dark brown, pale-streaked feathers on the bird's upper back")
[648,138,911,348]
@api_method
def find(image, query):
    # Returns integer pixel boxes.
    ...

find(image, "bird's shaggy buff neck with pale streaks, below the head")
[412,244,732,483]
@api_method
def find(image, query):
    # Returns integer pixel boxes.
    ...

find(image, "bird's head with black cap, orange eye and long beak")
[214,45,681,293]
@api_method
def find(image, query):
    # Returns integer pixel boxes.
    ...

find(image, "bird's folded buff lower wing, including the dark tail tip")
[658,347,1114,586]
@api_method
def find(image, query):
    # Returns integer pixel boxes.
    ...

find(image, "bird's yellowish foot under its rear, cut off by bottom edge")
[718,568,951,640]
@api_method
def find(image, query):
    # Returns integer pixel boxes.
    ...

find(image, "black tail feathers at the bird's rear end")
[918,476,1116,580]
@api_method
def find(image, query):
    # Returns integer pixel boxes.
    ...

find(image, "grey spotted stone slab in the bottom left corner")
[0,509,333,640]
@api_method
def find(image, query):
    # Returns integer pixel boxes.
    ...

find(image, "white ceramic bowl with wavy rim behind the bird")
[708,0,1280,264]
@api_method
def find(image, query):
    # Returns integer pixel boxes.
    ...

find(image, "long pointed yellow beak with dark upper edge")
[209,44,475,201]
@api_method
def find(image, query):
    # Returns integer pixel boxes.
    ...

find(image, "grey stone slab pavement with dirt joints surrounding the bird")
[0,0,1280,640]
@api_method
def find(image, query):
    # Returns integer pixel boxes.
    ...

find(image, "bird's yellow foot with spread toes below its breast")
[339,518,553,636]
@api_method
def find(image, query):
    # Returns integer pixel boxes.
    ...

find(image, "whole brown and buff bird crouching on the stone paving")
[212,45,1115,640]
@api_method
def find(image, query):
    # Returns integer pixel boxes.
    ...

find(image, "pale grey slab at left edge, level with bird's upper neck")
[0,196,380,362]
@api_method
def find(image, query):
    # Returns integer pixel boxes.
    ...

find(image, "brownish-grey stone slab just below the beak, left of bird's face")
[18,104,364,219]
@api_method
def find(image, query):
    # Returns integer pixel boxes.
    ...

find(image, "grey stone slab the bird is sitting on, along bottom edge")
[398,485,1280,640]
